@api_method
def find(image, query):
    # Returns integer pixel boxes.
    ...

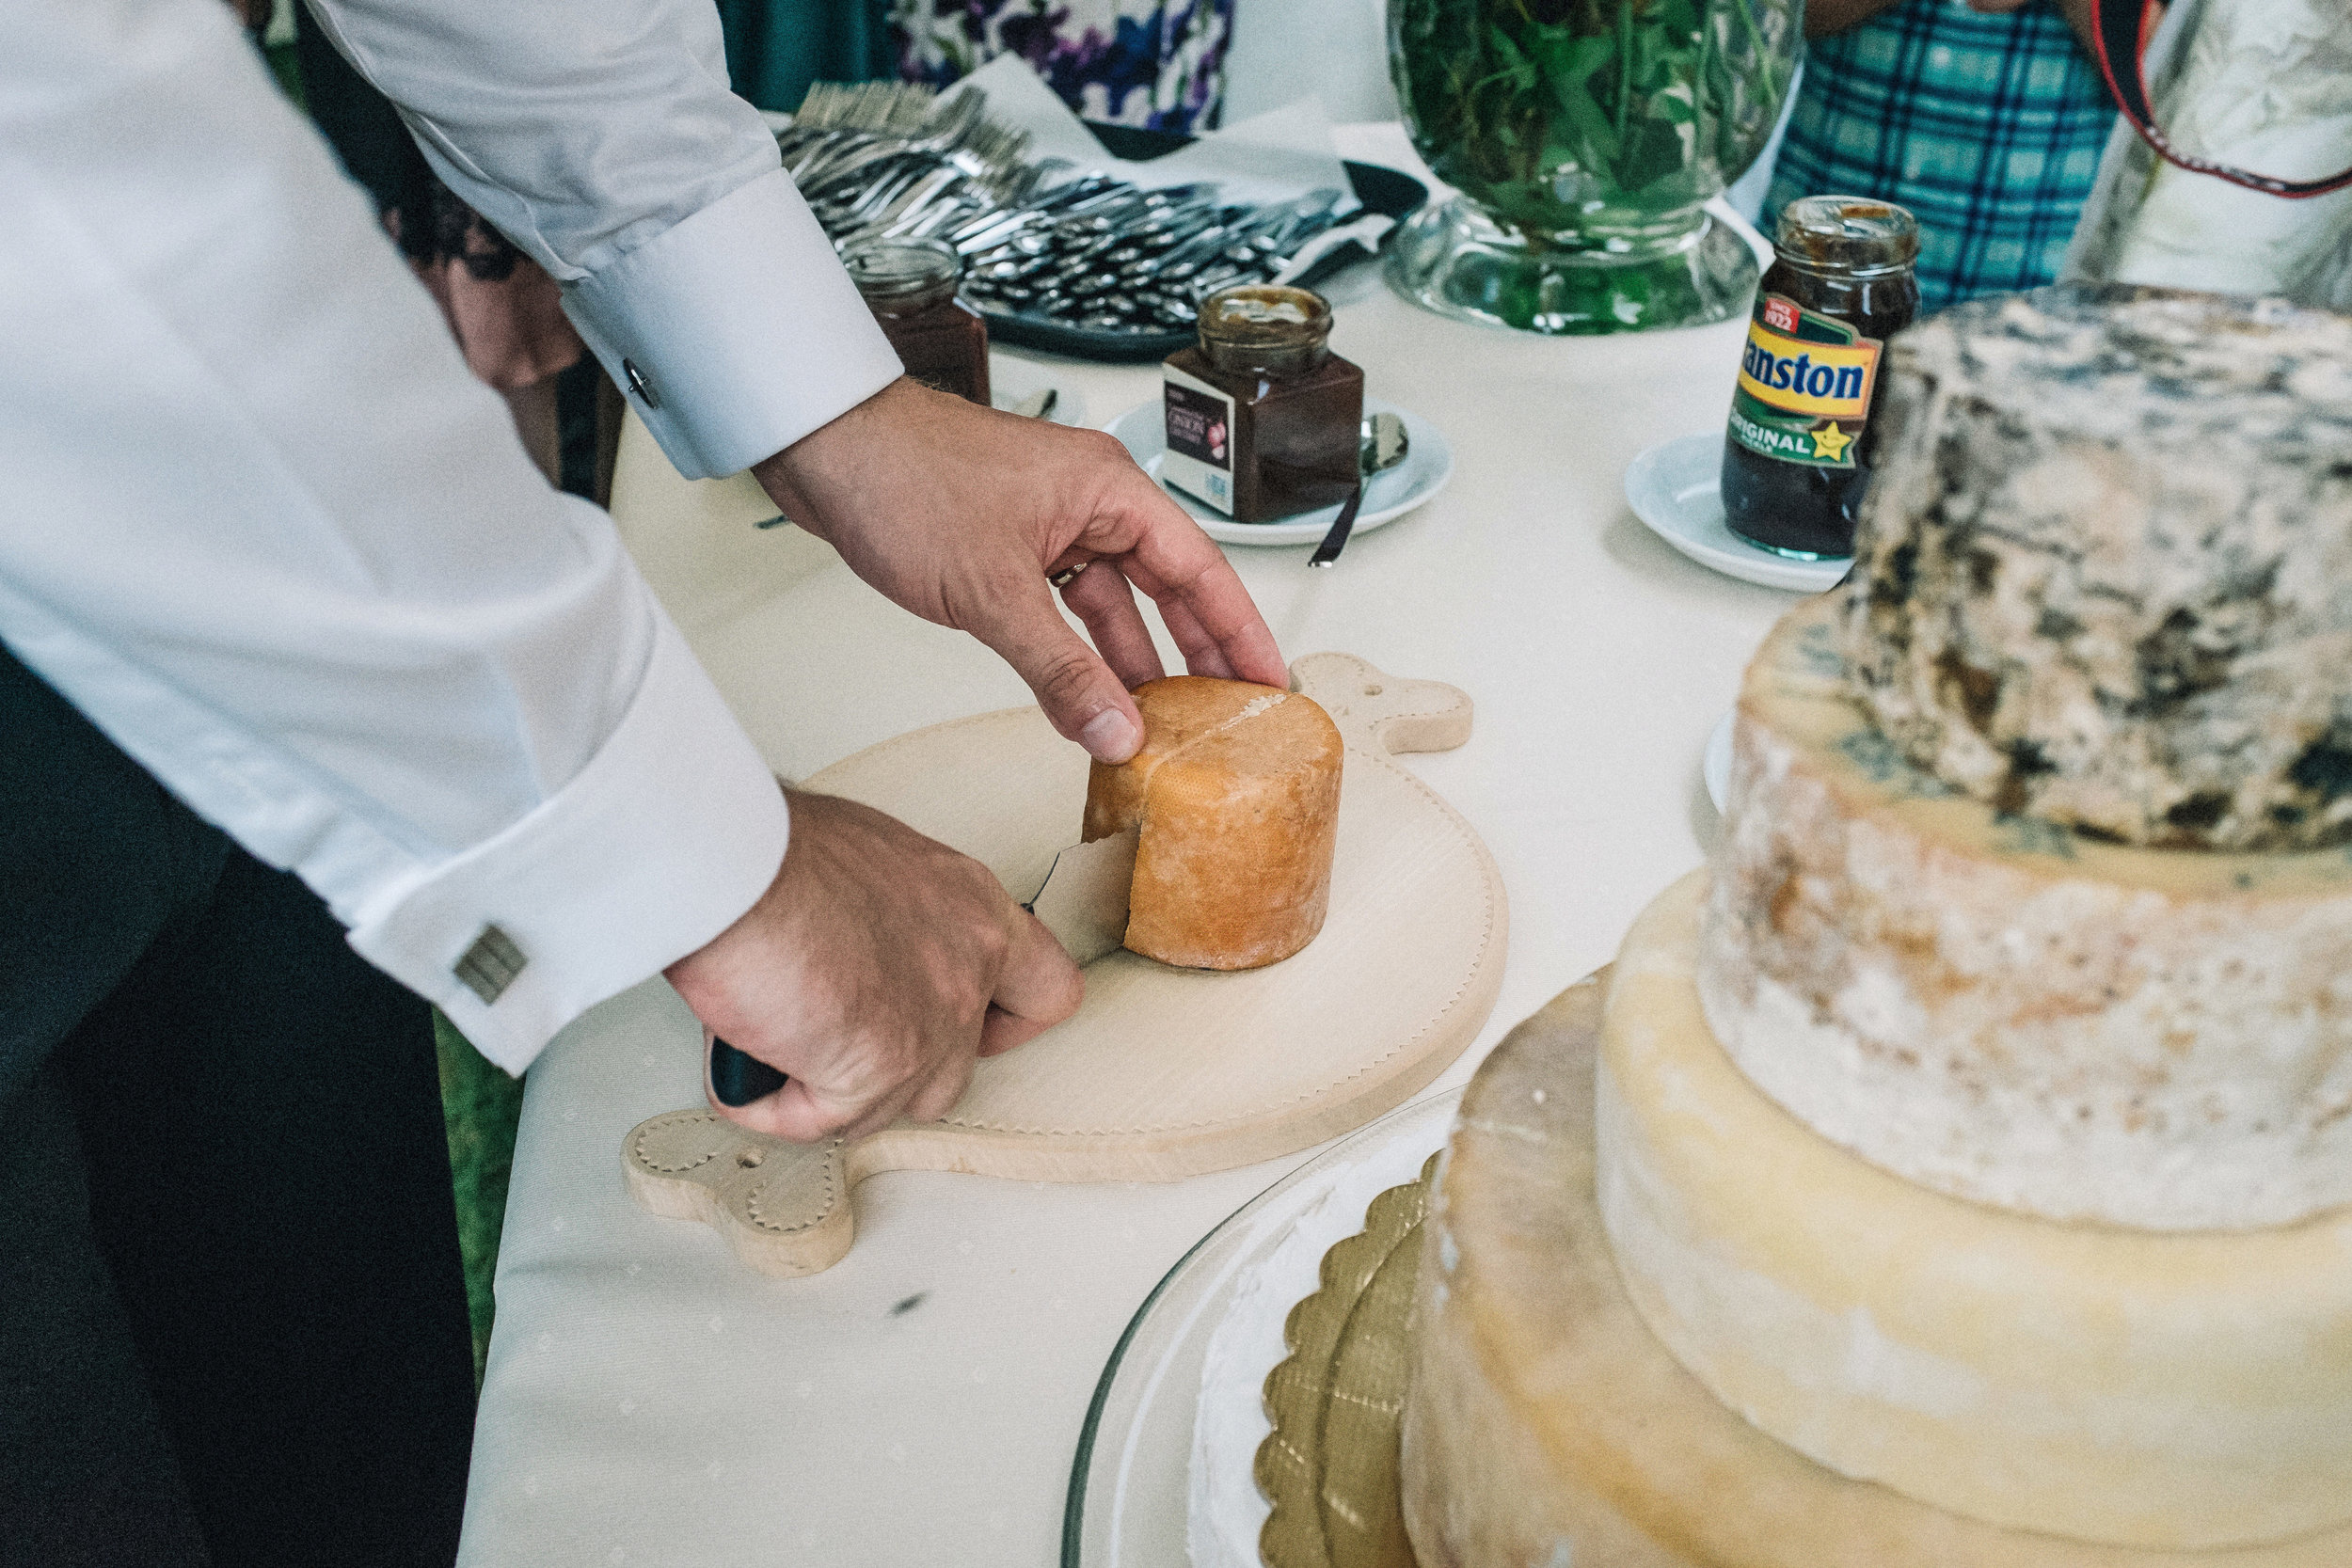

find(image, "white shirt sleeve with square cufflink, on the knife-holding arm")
[0,0,788,1069]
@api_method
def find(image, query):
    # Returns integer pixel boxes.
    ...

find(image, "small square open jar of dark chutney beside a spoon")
[1160,284,1364,522]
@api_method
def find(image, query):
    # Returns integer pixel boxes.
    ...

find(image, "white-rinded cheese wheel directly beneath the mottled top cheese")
[1698,599,2352,1231]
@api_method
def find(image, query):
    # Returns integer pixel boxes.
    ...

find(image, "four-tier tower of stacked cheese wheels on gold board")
[1405,289,2352,1568]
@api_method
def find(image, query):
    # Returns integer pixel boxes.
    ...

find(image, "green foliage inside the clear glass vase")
[1388,0,1797,237]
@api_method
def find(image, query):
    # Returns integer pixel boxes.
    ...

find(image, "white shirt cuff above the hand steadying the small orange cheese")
[564,169,903,480]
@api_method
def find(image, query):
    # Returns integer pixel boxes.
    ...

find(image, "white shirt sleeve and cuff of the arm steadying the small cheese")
[310,0,901,480]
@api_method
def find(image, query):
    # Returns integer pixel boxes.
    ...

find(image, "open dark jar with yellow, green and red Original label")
[1724,195,1919,560]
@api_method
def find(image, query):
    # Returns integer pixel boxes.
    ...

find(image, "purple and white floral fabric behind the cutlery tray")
[889,0,1232,132]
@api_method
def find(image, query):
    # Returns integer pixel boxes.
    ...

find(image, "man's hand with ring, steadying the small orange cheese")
[753,378,1289,762]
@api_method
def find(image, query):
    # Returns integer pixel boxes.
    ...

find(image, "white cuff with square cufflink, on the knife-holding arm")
[351,611,788,1072]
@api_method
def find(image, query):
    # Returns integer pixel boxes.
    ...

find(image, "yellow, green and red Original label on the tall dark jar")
[1729,293,1880,467]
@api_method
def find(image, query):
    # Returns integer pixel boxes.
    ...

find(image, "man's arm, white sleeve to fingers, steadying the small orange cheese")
[294,0,1287,759]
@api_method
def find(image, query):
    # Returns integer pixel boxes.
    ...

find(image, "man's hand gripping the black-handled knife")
[666,792,1085,1143]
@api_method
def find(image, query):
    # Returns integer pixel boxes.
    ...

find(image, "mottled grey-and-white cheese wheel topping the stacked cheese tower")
[1847,287,2352,864]
